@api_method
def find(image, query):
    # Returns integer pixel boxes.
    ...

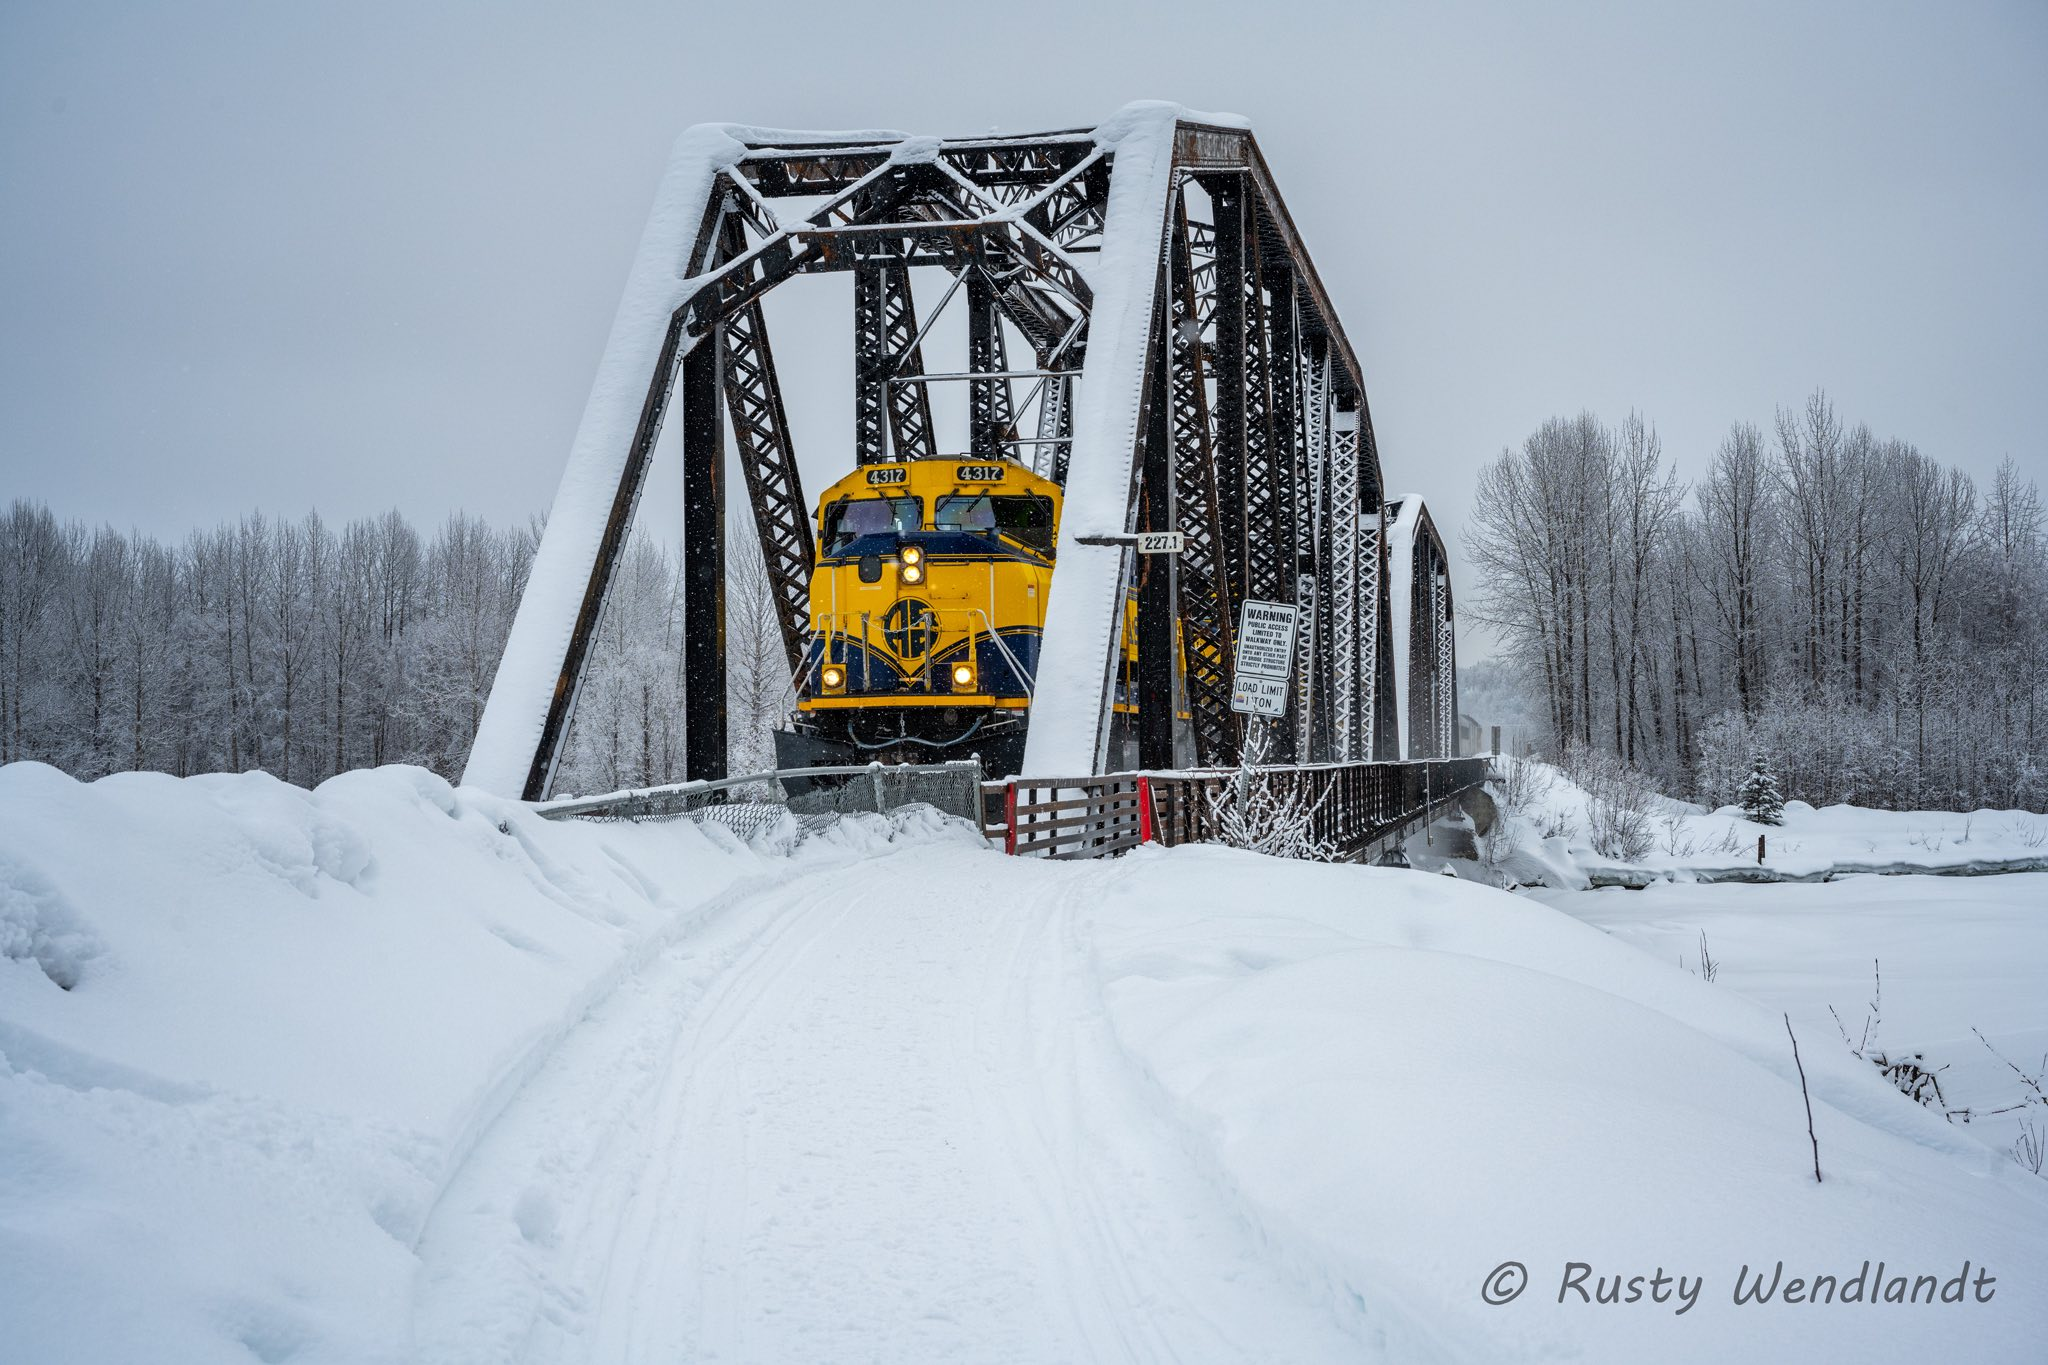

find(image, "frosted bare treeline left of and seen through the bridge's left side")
[0,501,786,792]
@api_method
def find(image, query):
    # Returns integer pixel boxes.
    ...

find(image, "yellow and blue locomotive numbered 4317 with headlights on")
[776,456,1061,772]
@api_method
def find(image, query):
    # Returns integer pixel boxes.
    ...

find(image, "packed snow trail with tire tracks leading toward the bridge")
[420,847,1368,1361]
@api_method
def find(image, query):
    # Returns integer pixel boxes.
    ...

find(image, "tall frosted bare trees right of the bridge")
[1464,393,2048,810]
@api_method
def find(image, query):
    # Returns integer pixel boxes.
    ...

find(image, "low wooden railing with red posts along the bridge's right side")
[983,759,1487,860]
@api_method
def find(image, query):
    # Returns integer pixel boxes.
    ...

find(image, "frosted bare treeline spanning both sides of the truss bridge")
[0,384,2048,808]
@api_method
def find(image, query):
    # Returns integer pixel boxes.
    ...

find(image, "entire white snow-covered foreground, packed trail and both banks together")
[0,767,2048,1361]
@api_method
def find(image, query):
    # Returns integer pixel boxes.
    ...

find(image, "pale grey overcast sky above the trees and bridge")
[0,0,2048,650]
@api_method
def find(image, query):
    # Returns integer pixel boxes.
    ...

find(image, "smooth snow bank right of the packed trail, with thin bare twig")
[1094,847,2048,1361]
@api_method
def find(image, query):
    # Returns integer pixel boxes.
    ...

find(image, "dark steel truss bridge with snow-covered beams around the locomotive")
[465,104,1458,855]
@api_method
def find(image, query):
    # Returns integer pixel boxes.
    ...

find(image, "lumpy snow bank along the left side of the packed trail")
[0,763,970,1361]
